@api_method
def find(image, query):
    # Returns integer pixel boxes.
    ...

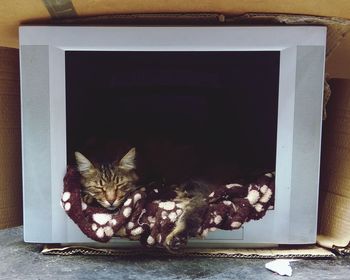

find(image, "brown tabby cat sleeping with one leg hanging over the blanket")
[75,145,266,252]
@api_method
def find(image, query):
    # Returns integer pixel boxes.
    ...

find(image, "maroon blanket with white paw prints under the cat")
[61,167,275,250]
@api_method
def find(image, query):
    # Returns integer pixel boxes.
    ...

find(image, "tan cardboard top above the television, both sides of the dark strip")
[0,0,350,48]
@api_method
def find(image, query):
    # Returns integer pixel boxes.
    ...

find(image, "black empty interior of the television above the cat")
[66,51,280,183]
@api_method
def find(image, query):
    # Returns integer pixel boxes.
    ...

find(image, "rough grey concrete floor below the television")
[0,227,350,280]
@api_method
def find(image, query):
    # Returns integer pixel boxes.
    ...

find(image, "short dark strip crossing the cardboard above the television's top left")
[43,0,77,19]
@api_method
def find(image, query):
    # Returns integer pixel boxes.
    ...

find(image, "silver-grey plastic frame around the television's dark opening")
[19,26,326,247]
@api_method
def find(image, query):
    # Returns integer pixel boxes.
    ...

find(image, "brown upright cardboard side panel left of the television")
[0,48,22,228]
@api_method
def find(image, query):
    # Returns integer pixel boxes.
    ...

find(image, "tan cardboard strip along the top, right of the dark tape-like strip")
[72,0,350,18]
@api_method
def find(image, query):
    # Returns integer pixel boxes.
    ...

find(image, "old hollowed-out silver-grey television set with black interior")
[19,26,326,247]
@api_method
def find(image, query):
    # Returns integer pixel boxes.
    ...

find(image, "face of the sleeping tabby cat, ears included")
[75,148,138,210]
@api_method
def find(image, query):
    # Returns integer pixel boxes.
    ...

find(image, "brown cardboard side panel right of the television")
[318,80,350,248]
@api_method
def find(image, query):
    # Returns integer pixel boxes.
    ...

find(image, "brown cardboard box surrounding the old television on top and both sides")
[0,0,350,258]
